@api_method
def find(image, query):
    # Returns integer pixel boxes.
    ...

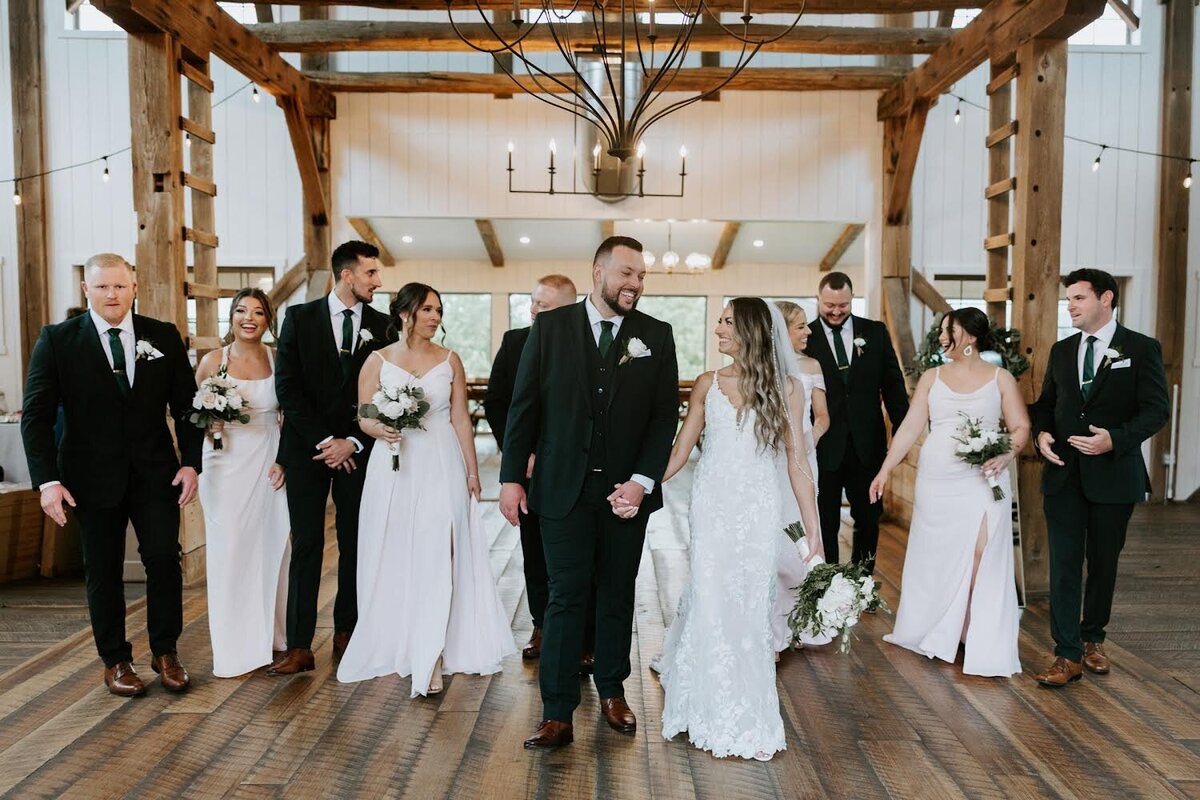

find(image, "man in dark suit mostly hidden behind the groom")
[484,275,595,674]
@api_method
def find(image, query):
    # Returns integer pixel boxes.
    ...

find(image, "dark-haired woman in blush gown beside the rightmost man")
[870,308,1030,678]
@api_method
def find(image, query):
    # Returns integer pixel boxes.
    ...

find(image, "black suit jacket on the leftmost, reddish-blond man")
[20,314,204,509]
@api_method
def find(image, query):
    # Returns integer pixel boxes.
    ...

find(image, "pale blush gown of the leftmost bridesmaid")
[199,345,292,678]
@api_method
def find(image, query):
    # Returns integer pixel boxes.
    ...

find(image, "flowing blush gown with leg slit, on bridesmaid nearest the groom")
[337,353,516,697]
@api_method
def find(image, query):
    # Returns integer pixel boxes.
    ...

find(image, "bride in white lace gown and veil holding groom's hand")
[655,297,821,760]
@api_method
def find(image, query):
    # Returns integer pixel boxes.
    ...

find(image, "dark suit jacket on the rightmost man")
[1030,325,1170,504]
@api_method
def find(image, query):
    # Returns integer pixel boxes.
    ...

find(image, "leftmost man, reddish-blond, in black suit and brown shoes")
[20,253,203,697]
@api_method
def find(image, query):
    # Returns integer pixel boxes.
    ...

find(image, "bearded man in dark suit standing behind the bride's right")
[805,272,908,570]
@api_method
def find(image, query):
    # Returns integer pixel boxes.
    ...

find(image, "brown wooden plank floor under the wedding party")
[0,457,1200,800]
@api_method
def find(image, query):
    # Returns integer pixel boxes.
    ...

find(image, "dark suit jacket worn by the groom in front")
[500,302,679,519]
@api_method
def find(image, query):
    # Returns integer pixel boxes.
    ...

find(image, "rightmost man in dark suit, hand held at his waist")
[1031,269,1170,687]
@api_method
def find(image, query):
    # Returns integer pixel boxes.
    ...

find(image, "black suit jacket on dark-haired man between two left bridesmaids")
[275,295,394,467]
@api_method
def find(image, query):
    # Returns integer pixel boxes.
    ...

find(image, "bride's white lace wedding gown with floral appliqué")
[655,377,791,758]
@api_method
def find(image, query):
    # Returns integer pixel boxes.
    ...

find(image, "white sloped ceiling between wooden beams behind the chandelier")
[368,217,865,267]
